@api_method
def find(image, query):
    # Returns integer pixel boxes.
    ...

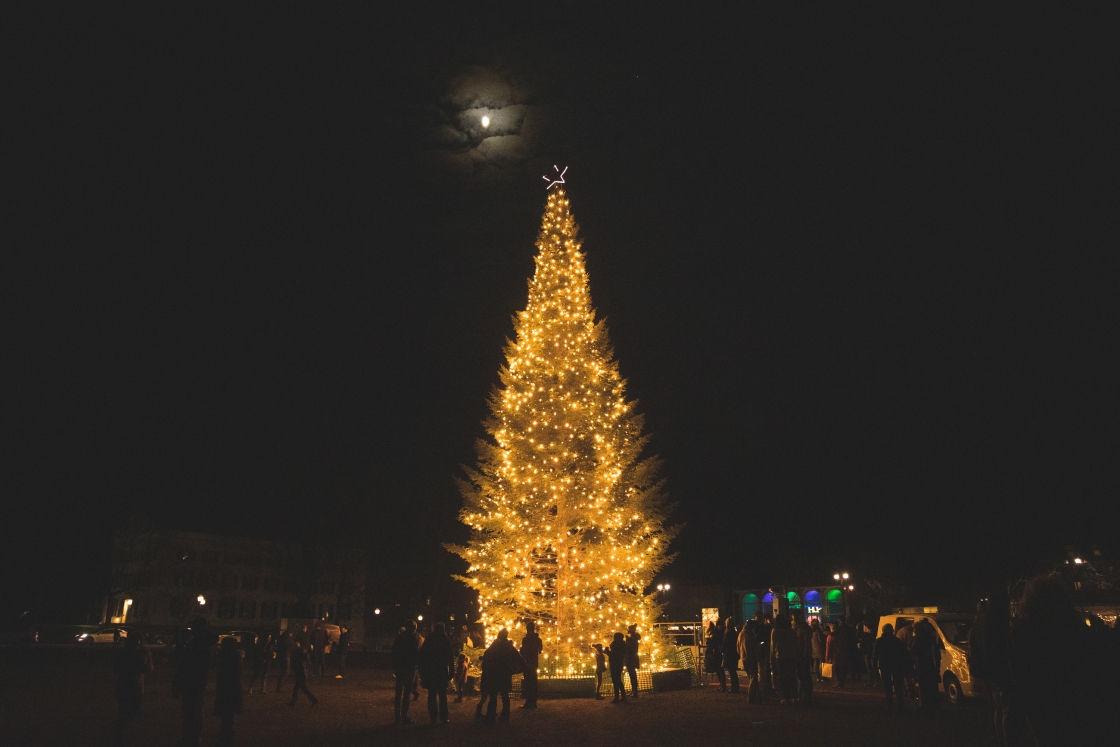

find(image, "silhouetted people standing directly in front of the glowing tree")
[392,620,642,725]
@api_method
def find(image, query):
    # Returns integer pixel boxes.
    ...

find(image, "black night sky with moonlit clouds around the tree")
[2,2,1120,609]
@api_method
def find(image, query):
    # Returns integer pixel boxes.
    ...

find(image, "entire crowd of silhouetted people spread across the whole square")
[114,578,1120,747]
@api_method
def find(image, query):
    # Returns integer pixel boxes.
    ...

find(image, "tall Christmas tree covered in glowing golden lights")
[449,187,673,673]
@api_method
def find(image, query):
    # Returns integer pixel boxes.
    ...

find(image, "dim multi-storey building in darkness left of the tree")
[102,531,365,643]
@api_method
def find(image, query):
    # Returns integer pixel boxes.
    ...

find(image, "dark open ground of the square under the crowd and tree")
[0,646,988,747]
